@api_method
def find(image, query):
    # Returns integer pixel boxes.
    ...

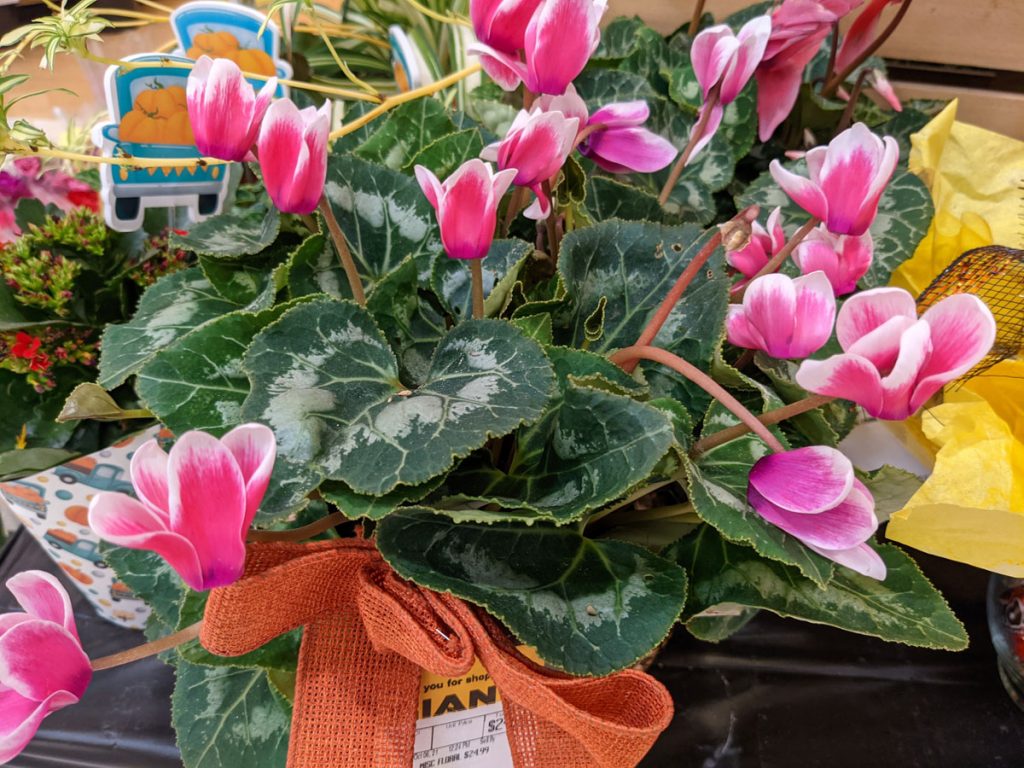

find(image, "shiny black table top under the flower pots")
[0,532,1024,768]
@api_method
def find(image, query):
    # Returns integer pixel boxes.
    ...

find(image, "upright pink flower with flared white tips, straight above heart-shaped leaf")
[416,159,516,259]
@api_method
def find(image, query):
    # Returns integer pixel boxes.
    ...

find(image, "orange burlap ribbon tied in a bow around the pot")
[200,539,673,768]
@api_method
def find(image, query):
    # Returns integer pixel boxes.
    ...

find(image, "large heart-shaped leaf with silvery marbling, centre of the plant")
[243,299,553,496]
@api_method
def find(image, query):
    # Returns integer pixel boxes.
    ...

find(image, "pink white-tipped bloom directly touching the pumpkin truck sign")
[185,56,278,162]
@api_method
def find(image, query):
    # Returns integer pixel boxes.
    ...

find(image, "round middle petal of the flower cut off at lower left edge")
[0,620,92,701]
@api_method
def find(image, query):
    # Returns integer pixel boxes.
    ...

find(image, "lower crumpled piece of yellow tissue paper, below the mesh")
[886,397,1024,578]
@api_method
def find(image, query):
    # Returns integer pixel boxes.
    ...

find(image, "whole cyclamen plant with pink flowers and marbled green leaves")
[0,0,995,766]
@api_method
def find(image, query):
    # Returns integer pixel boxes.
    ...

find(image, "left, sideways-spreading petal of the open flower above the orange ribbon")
[89,492,203,589]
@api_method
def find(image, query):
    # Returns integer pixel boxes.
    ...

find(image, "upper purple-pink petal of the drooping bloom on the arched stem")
[750,445,855,515]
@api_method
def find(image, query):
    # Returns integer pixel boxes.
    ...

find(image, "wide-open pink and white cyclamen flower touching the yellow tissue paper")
[797,288,995,421]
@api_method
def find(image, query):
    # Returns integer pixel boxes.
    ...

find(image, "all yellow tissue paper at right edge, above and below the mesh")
[887,101,1024,578]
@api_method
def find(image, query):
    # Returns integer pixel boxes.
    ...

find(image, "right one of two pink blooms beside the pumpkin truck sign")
[258,98,331,214]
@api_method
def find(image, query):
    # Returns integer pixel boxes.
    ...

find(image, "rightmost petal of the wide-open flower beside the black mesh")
[910,294,996,411]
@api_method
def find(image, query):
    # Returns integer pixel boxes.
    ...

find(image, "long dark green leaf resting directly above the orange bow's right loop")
[377,508,686,675]
